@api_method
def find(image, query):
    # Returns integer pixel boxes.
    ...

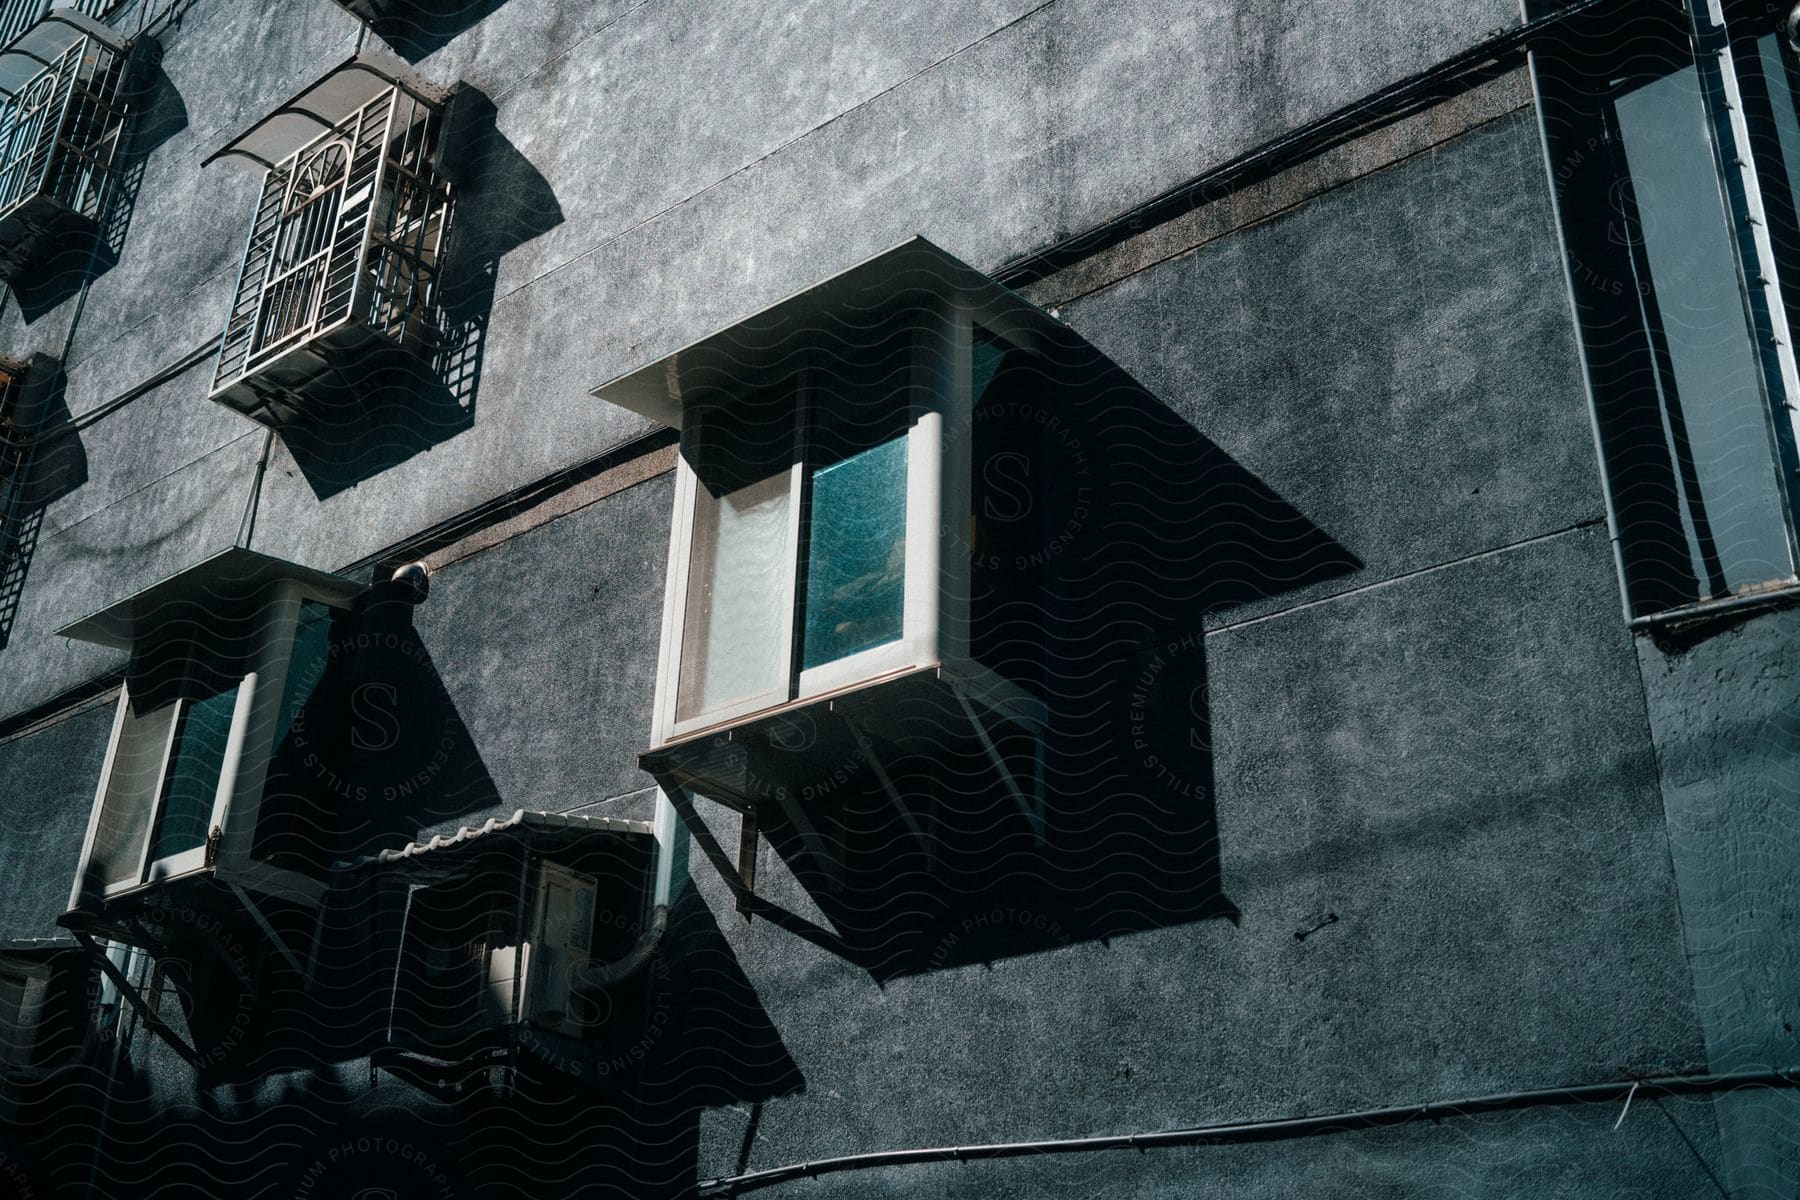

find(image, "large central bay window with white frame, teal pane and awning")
[594,237,1072,852]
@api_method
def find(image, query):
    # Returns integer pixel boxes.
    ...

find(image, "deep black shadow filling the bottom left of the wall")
[15,889,805,1198]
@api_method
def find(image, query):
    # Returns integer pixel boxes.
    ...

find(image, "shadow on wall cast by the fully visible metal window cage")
[283,86,563,500]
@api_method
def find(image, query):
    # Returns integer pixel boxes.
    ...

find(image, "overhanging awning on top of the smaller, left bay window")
[58,547,365,649]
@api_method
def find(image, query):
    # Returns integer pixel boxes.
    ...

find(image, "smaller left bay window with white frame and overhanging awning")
[59,549,362,912]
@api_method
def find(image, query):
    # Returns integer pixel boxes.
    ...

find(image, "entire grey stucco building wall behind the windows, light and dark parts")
[0,0,1796,1196]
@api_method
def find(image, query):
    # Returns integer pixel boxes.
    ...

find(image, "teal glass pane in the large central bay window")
[801,437,905,667]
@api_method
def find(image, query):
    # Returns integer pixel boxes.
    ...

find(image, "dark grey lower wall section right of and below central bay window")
[673,115,1721,1196]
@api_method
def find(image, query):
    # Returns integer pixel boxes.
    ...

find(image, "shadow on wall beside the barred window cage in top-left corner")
[13,47,187,324]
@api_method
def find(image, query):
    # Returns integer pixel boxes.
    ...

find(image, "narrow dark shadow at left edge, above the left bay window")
[0,354,88,649]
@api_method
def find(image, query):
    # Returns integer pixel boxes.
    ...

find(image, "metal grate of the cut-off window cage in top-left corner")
[0,14,128,259]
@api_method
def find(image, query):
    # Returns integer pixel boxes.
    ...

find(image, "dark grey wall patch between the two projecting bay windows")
[389,475,673,845]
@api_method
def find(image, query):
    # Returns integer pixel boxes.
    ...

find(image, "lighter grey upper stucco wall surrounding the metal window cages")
[0,0,1517,714]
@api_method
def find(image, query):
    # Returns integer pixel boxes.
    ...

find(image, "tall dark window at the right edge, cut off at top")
[1539,0,1800,615]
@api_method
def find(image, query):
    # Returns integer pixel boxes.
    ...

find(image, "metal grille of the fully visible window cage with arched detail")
[212,86,450,396]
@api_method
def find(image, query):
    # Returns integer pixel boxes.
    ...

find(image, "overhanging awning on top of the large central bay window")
[592,237,1080,428]
